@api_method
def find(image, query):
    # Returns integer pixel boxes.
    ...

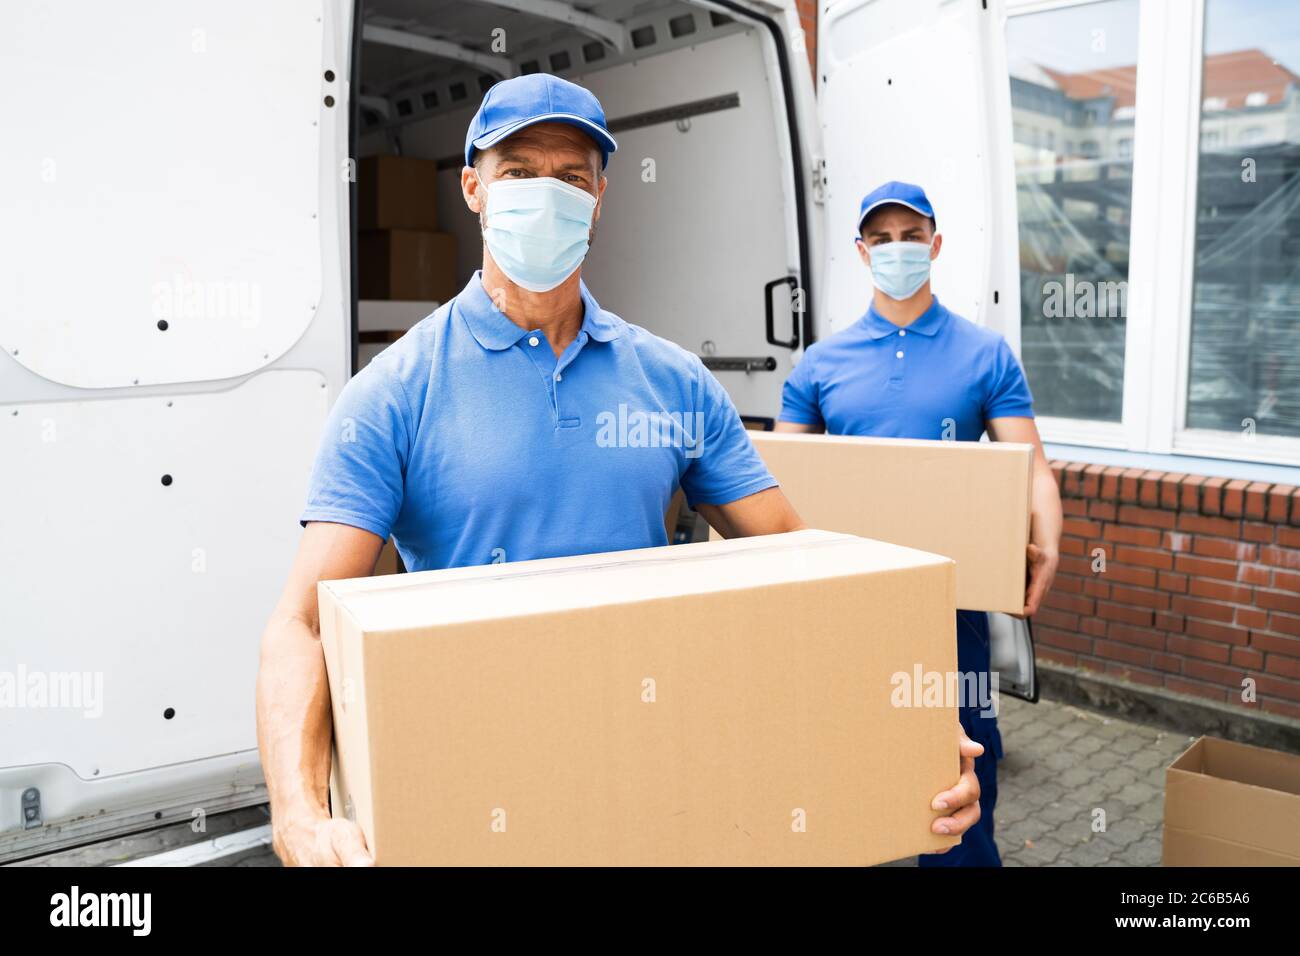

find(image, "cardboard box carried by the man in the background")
[728,432,1034,614]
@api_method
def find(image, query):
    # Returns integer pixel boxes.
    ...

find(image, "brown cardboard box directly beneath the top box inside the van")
[356,229,460,302]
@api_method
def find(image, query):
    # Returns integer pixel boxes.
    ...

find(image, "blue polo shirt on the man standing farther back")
[781,297,1034,441]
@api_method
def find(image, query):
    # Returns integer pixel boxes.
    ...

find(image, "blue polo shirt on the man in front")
[302,273,776,571]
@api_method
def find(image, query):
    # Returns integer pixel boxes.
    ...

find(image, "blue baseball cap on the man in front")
[465,73,619,169]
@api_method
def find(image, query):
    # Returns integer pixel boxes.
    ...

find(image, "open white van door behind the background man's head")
[818,0,1019,351]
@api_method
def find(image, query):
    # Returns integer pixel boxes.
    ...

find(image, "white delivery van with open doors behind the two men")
[0,0,1019,860]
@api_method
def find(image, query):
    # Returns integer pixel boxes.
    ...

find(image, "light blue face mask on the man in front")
[478,177,595,293]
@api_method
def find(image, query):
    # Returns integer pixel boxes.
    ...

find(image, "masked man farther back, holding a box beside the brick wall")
[776,182,1061,866]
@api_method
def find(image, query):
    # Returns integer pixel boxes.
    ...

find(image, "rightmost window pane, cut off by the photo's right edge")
[1186,0,1300,438]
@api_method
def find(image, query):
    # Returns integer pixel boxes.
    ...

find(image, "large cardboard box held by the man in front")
[319,531,958,865]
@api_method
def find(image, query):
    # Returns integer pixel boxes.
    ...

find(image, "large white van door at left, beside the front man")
[0,0,352,860]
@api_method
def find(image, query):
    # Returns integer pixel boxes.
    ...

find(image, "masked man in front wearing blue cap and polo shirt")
[257,74,980,865]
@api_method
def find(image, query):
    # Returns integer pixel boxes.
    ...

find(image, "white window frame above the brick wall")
[1005,0,1300,464]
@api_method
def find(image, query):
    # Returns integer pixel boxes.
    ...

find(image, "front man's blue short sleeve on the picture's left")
[300,362,410,538]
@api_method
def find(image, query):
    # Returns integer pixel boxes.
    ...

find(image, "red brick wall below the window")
[1034,462,1300,718]
